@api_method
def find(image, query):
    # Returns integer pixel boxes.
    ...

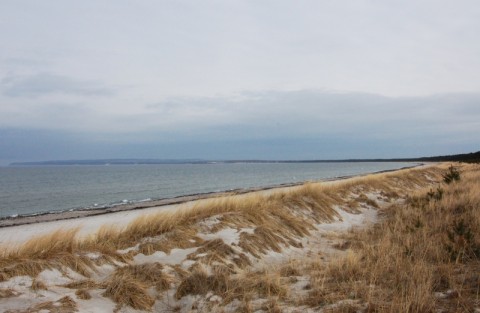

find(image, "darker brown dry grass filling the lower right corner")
[296,162,480,312]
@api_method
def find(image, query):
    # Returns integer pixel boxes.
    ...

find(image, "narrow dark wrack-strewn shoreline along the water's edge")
[0,163,426,229]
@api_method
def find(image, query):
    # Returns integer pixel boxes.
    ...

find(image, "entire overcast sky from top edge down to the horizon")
[0,0,480,165]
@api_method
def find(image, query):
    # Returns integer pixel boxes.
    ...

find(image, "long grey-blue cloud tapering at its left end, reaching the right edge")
[138,90,480,140]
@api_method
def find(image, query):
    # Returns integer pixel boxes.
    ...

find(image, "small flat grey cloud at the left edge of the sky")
[2,73,114,97]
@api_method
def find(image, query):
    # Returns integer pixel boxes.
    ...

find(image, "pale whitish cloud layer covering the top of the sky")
[0,0,480,100]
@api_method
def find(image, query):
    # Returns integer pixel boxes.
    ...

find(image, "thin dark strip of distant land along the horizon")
[9,151,480,166]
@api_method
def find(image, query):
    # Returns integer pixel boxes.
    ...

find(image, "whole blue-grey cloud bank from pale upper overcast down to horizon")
[0,90,480,163]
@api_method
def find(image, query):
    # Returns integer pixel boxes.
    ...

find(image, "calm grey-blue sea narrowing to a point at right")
[0,162,417,219]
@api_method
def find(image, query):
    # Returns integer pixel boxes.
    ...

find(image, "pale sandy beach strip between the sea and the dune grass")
[0,165,422,245]
